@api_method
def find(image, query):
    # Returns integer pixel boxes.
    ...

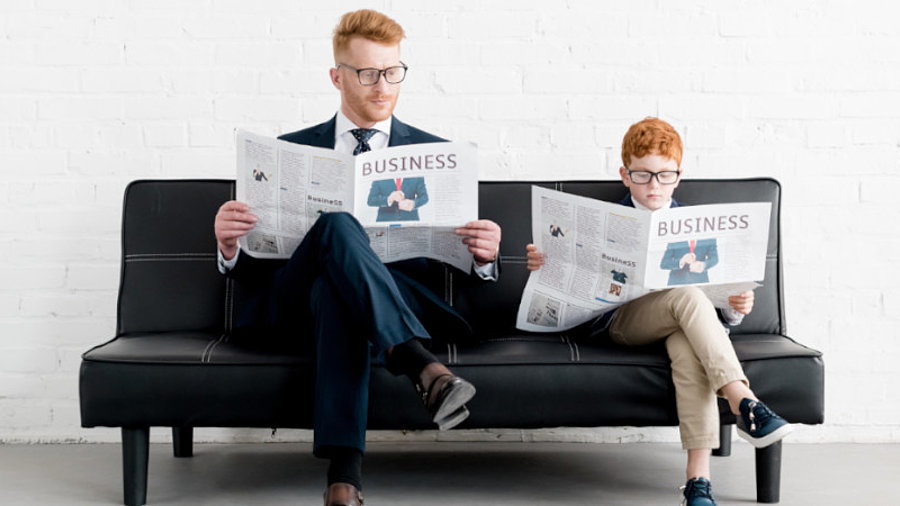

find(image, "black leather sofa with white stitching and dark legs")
[80,179,824,505]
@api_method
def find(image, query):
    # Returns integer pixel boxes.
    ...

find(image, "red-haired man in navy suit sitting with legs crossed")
[215,10,500,505]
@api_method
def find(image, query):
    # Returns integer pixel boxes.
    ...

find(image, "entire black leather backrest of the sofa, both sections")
[117,179,785,335]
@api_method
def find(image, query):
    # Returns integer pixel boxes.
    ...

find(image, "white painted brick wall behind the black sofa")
[0,0,900,442]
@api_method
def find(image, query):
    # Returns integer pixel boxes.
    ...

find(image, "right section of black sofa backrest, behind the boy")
[451,178,785,335]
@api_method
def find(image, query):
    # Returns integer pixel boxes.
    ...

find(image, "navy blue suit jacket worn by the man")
[228,116,472,340]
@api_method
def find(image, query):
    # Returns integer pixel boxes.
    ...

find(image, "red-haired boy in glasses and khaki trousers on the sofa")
[526,118,791,506]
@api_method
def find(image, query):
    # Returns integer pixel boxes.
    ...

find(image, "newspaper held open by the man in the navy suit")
[237,131,478,272]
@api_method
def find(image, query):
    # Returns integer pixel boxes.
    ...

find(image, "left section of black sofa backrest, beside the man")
[117,180,234,335]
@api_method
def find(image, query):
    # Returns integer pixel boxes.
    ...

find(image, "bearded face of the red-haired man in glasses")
[331,37,400,128]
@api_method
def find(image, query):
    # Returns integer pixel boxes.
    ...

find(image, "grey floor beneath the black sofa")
[0,442,900,506]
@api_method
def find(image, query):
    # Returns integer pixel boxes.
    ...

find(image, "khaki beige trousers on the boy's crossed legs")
[609,286,749,450]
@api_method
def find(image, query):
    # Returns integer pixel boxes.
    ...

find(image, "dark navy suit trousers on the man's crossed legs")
[269,213,430,457]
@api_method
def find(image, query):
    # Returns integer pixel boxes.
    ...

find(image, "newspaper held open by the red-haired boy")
[516,186,771,332]
